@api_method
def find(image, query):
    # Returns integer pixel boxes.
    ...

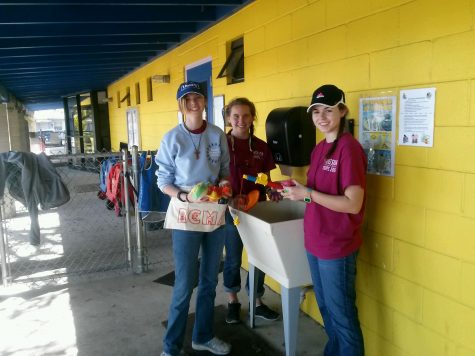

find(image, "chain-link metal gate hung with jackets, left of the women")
[0,153,171,285]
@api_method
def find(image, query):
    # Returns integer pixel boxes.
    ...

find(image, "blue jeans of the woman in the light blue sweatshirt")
[163,227,224,355]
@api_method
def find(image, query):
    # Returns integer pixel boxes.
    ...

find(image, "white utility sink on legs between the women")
[229,200,312,356]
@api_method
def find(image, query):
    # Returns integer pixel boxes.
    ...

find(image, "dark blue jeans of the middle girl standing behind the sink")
[223,212,265,298]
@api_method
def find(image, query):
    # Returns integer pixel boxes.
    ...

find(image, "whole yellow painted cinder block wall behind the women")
[108,0,475,356]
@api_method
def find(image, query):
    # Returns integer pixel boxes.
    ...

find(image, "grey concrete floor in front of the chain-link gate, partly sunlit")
[0,241,326,356]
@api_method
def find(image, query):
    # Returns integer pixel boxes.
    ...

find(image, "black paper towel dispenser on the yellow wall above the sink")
[266,106,316,167]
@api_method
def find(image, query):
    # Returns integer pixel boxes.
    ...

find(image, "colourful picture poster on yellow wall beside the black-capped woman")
[359,96,396,176]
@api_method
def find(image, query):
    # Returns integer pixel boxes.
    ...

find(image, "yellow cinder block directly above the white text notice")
[370,42,432,87]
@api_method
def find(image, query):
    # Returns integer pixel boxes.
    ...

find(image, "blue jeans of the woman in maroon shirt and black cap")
[307,252,364,356]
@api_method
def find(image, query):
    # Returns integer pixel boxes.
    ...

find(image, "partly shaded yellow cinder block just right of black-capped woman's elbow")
[364,199,426,247]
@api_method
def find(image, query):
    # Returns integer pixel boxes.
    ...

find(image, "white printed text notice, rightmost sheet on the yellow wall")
[399,88,435,147]
